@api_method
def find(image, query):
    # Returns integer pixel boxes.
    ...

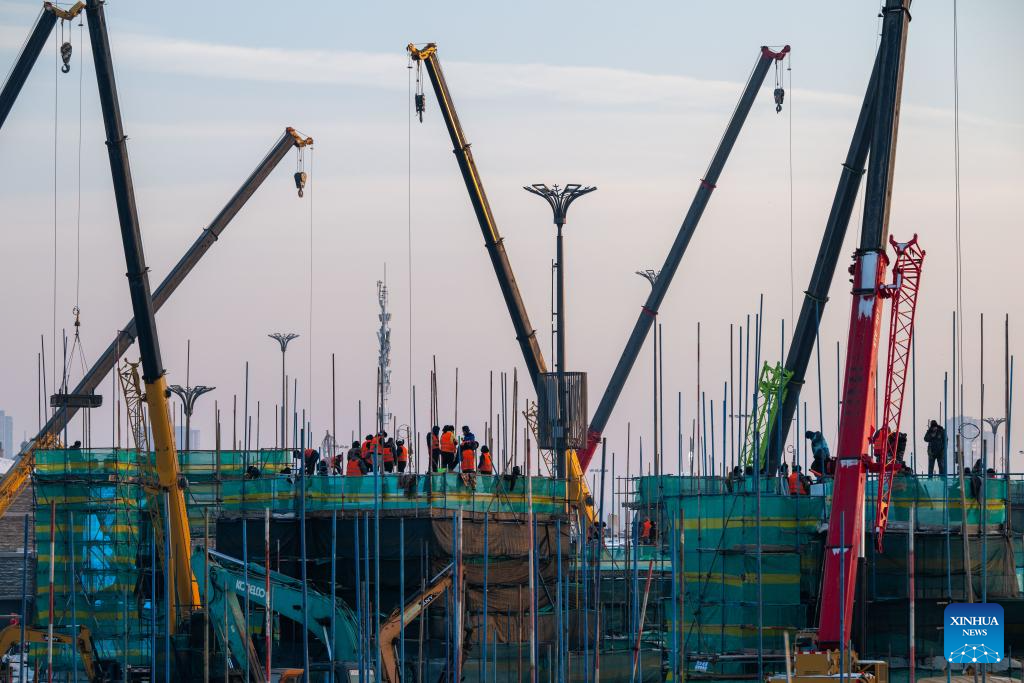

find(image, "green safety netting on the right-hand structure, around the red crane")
[626,475,1024,678]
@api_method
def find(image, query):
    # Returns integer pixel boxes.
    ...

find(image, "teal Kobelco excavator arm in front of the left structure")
[191,547,359,683]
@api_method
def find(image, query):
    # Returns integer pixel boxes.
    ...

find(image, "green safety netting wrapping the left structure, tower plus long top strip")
[32,449,566,671]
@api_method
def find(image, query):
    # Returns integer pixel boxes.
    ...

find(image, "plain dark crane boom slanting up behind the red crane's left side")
[767,50,882,474]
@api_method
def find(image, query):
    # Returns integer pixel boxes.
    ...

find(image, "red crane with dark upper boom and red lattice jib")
[778,0,924,683]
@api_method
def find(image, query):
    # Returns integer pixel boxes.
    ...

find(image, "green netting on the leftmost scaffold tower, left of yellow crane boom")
[32,451,152,671]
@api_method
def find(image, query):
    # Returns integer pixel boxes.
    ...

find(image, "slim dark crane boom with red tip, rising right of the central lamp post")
[579,45,790,472]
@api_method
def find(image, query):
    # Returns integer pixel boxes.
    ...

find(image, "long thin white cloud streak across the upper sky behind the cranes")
[0,23,1007,127]
